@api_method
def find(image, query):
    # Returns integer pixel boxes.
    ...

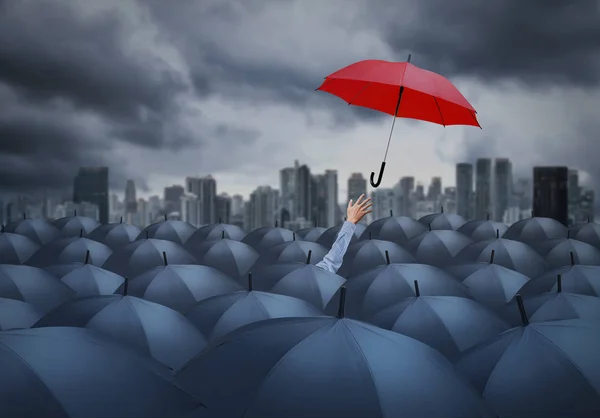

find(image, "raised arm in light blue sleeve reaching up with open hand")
[316,195,372,273]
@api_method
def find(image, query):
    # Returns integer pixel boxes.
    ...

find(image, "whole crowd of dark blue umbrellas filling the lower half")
[0,213,600,418]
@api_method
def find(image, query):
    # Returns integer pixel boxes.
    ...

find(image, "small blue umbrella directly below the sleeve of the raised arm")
[253,264,346,309]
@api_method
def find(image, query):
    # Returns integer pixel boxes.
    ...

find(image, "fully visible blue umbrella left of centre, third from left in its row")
[121,264,243,312]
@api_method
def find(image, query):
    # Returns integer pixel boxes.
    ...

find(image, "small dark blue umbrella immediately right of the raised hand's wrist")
[360,216,427,245]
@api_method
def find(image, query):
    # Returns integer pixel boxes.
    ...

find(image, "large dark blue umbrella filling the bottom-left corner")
[0,327,202,418]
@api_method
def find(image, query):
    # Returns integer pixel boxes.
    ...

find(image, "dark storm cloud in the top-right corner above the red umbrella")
[375,0,600,87]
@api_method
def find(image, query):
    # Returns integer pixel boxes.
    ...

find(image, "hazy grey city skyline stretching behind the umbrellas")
[0,158,594,230]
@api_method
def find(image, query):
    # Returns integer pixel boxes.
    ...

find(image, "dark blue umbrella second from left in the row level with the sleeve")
[27,237,112,267]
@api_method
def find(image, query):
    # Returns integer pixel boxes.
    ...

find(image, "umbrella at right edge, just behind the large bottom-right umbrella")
[498,282,600,326]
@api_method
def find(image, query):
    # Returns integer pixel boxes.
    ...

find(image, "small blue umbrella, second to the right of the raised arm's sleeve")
[406,230,473,267]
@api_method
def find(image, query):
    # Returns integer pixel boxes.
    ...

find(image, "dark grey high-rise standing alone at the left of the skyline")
[73,167,109,224]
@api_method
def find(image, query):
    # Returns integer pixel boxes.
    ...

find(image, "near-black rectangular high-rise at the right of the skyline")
[533,167,569,226]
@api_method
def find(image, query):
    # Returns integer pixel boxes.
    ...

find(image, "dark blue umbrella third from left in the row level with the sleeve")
[102,239,198,278]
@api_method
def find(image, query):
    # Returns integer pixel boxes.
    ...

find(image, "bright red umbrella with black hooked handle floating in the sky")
[316,55,481,187]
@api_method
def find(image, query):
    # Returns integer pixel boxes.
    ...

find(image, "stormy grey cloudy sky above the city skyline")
[0,0,600,200]
